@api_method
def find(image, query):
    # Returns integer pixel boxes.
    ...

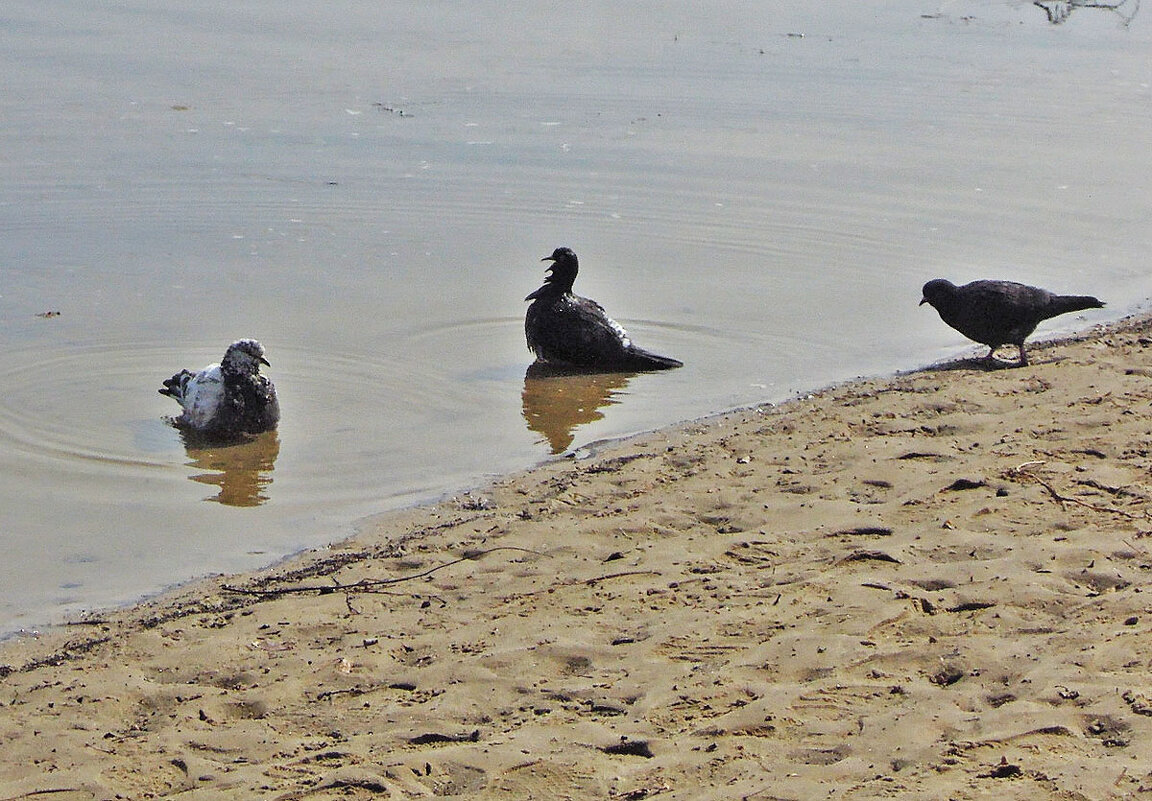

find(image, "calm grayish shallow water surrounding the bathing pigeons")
[0,0,1152,633]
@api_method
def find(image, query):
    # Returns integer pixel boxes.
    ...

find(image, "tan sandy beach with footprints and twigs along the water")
[0,319,1152,799]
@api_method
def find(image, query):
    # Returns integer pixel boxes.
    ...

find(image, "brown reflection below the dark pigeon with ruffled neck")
[522,362,636,454]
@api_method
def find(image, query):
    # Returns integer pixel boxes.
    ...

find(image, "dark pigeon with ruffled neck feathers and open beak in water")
[524,248,683,372]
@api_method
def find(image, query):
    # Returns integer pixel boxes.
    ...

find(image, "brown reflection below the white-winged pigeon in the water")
[181,430,280,506]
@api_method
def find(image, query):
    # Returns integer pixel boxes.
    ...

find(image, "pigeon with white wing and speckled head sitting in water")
[160,339,280,439]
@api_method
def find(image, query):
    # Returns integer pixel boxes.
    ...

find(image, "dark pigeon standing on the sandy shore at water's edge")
[920,278,1104,365]
